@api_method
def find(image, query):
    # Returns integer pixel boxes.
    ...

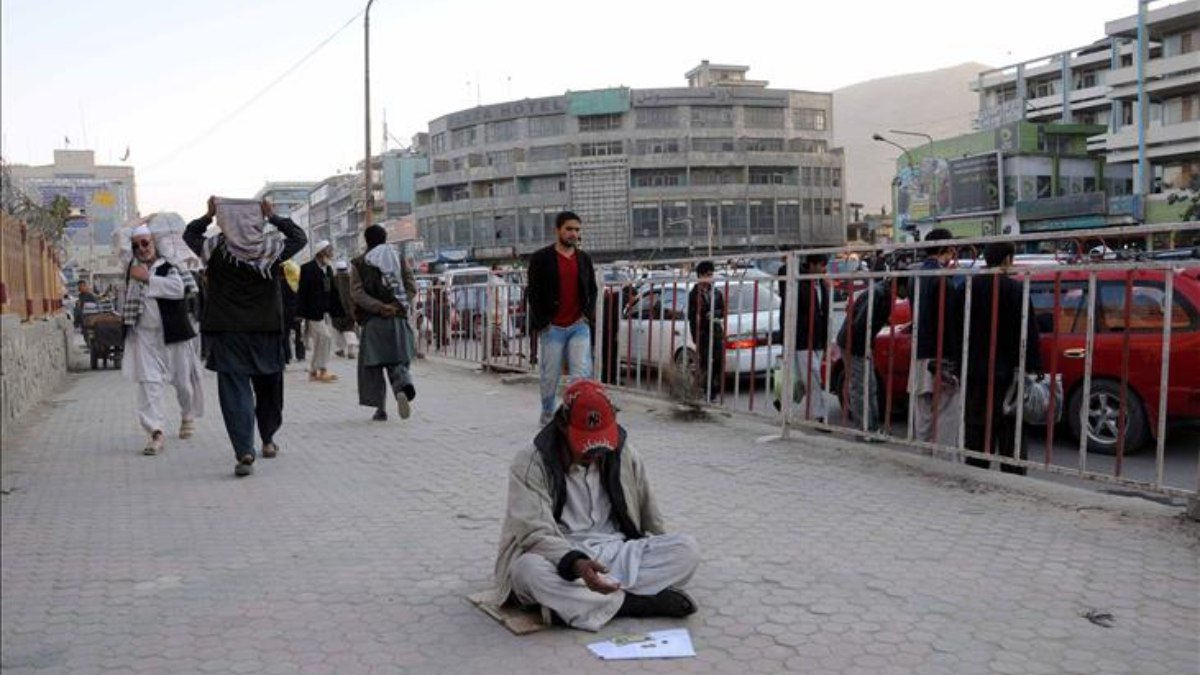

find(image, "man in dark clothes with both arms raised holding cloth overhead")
[184,197,308,476]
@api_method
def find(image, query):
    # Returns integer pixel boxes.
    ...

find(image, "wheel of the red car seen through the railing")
[1067,380,1150,455]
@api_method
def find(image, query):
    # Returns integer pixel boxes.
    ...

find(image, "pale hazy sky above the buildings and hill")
[0,0,1152,215]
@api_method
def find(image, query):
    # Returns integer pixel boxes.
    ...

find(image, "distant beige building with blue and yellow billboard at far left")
[8,150,138,273]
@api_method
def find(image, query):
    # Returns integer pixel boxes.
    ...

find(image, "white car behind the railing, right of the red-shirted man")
[617,277,784,375]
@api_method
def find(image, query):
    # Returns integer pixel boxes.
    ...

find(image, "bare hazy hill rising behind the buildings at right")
[833,62,991,215]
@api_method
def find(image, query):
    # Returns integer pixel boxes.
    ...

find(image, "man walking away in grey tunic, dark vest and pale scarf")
[350,225,416,422]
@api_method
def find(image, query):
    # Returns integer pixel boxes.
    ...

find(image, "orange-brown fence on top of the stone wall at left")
[0,214,62,321]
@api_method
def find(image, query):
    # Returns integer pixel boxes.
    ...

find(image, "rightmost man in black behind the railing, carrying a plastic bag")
[964,243,1042,476]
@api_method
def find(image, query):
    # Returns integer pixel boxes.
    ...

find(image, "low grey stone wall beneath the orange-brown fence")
[0,313,71,436]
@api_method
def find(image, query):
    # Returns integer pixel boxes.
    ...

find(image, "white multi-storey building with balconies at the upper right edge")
[972,0,1200,222]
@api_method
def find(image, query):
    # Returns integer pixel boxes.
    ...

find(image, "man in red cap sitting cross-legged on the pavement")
[496,380,700,631]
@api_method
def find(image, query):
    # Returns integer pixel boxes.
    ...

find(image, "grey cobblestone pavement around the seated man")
[0,353,1200,675]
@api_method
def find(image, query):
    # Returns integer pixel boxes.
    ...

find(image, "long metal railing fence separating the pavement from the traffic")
[416,223,1200,496]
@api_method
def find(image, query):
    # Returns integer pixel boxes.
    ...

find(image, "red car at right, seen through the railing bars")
[834,265,1200,454]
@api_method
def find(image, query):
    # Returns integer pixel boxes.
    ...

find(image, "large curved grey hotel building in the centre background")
[415,61,845,259]
